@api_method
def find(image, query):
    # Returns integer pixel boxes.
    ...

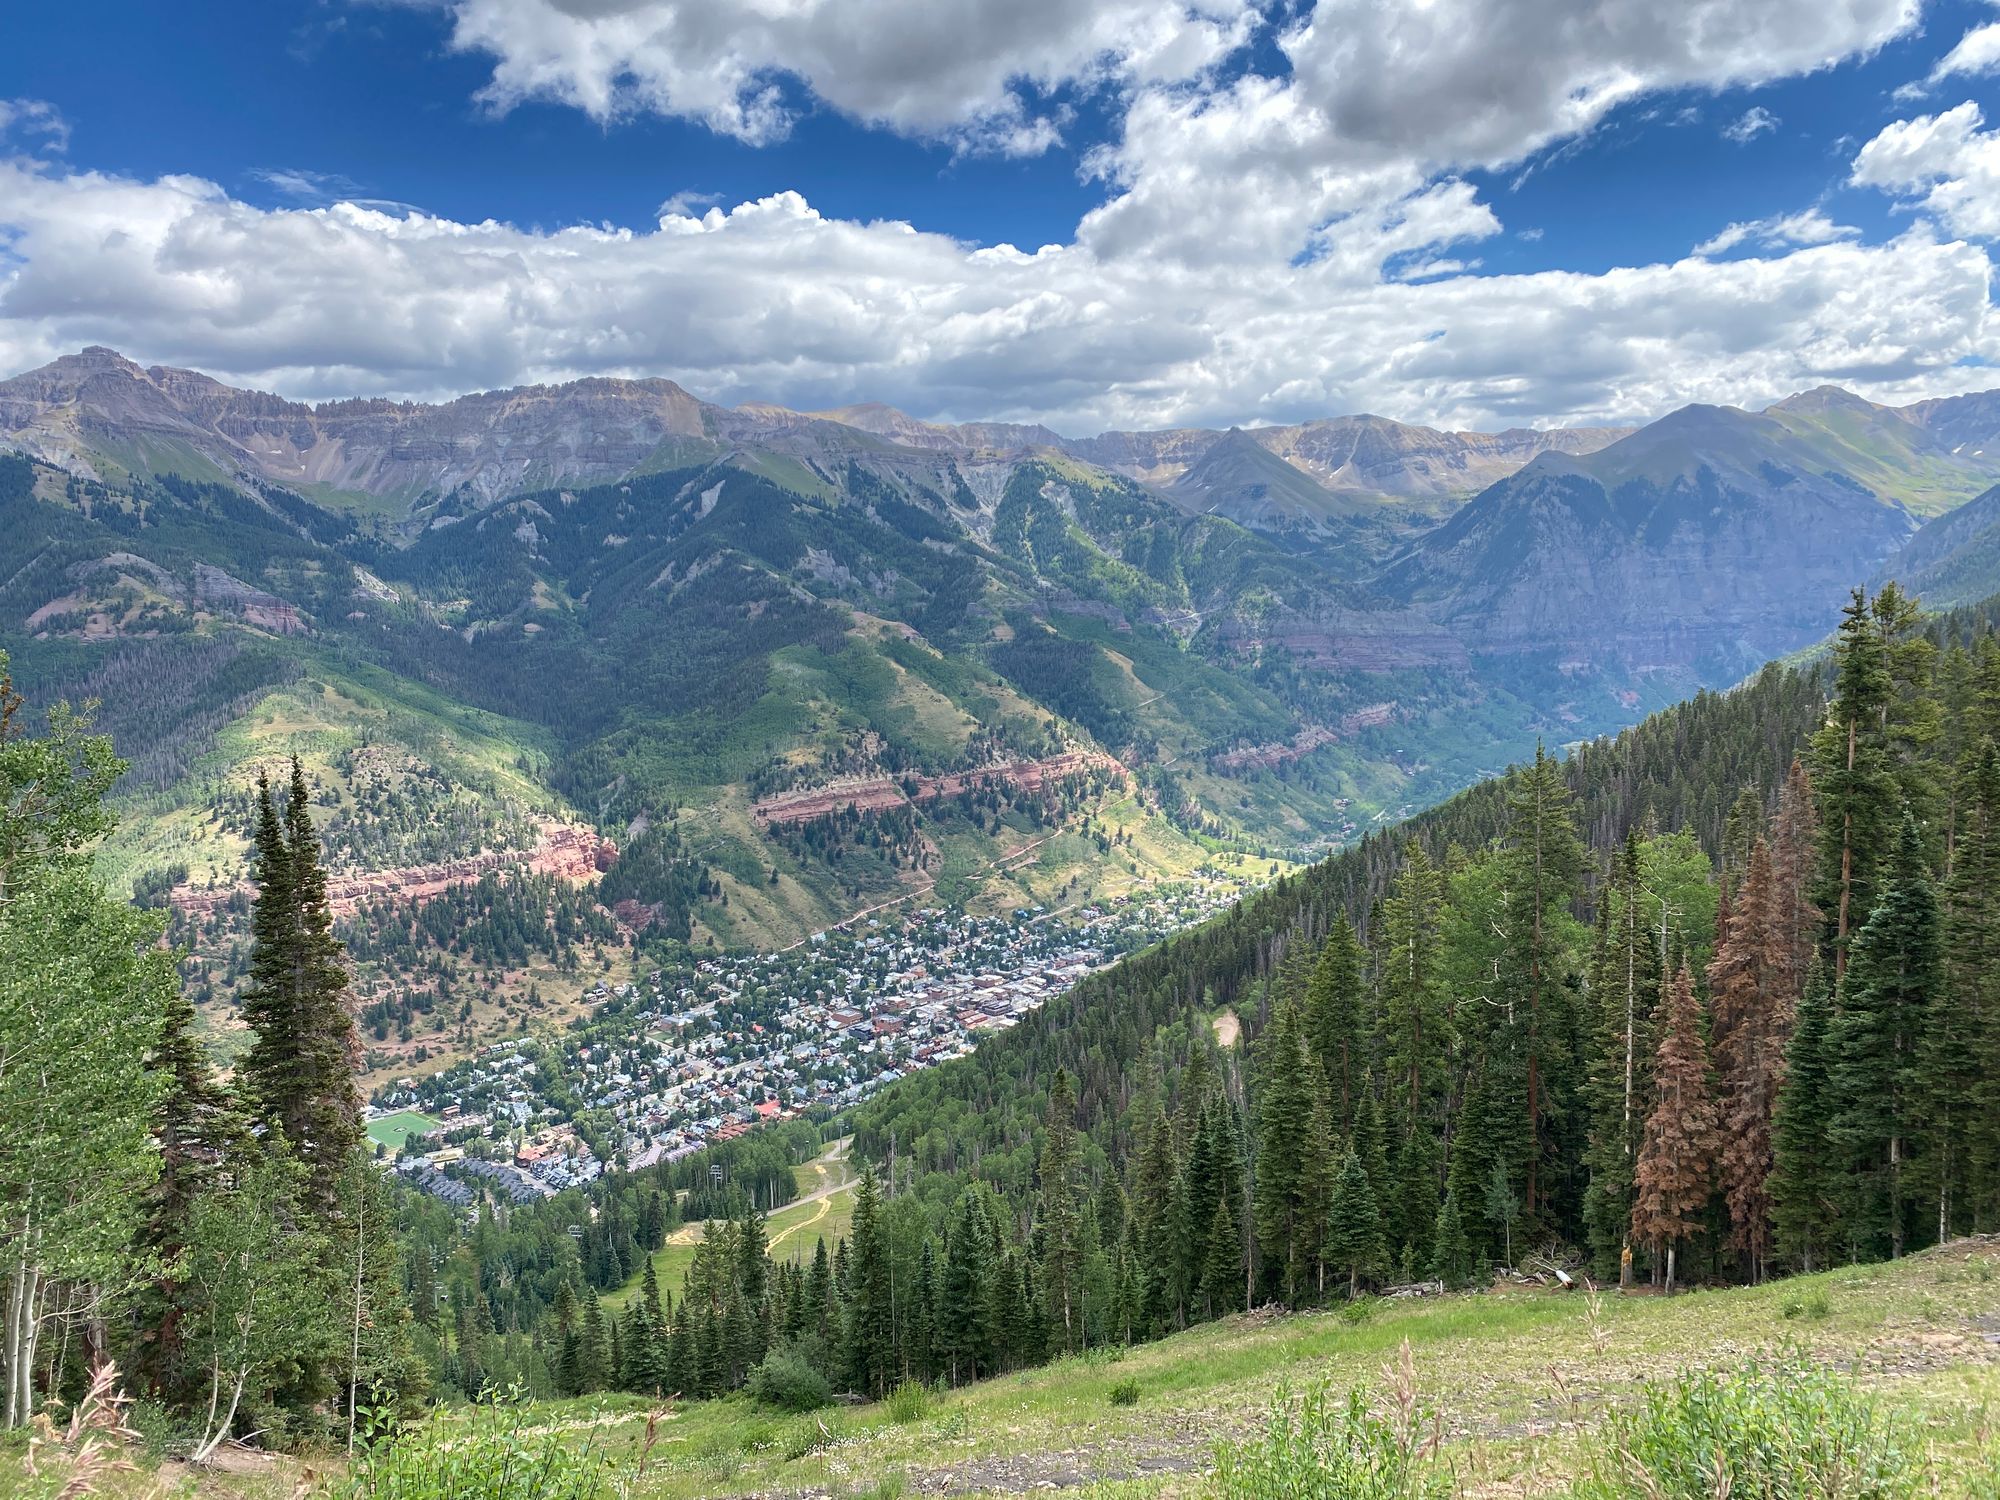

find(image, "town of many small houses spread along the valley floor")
[376,882,1240,1204]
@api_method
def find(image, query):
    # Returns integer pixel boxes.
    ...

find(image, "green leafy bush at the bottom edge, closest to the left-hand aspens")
[346,1406,612,1500]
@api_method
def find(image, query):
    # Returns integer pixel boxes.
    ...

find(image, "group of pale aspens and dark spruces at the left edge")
[0,658,426,1458]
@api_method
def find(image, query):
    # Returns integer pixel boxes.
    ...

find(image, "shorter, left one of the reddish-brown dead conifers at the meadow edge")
[1632,968,1720,1292]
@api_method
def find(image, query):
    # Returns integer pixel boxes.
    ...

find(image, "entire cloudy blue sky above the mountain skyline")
[0,0,2000,430]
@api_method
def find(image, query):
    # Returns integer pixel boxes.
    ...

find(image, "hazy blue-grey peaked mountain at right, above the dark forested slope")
[1378,406,1914,680]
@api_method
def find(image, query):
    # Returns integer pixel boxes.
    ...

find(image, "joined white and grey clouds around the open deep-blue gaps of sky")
[0,0,1976,432]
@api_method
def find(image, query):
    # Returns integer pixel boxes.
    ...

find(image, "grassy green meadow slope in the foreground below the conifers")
[27,1240,2000,1500]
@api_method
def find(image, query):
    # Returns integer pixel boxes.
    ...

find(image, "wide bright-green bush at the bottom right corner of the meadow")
[1582,1356,1924,1500]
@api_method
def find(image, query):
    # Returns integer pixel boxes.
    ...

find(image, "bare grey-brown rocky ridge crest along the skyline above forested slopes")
[0,348,1618,524]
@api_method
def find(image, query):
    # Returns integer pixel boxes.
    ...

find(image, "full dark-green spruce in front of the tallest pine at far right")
[1828,816,1942,1256]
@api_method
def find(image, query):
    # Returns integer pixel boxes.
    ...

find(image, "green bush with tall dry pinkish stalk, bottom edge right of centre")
[1214,1344,1452,1500]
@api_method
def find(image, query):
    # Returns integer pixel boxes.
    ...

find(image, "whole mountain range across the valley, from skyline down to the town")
[0,348,2000,1080]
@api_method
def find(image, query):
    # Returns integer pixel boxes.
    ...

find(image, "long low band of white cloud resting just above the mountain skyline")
[0,160,2000,432]
